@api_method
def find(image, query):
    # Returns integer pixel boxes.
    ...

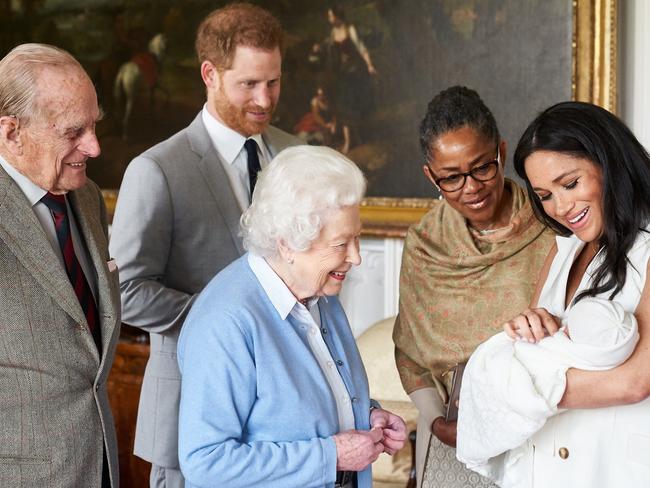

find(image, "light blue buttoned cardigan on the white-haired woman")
[177,255,372,488]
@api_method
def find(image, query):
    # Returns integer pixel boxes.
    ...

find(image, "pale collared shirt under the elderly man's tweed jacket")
[0,156,97,301]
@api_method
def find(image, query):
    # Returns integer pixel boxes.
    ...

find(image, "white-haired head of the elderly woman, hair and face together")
[241,146,366,300]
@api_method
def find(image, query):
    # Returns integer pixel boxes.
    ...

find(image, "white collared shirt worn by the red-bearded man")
[201,104,271,212]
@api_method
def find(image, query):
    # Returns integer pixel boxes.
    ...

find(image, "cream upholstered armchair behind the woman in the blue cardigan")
[357,317,418,488]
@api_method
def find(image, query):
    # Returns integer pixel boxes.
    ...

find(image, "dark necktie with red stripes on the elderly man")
[41,192,102,351]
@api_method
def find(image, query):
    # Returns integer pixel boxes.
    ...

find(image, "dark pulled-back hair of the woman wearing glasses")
[420,85,500,161]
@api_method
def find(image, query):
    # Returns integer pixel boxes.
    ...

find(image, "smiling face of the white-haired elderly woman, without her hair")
[280,205,361,300]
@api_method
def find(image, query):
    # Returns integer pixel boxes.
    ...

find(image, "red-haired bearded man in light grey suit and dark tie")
[110,3,299,487]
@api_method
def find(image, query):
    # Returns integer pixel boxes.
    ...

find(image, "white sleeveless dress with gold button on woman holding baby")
[504,232,650,488]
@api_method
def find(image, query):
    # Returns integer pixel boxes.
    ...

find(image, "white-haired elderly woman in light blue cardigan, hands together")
[178,146,406,488]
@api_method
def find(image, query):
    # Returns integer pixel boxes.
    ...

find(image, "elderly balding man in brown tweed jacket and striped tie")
[0,44,120,488]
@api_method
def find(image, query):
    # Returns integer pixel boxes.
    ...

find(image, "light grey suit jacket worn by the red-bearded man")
[110,113,300,469]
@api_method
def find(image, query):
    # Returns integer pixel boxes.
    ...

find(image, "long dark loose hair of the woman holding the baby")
[514,102,650,301]
